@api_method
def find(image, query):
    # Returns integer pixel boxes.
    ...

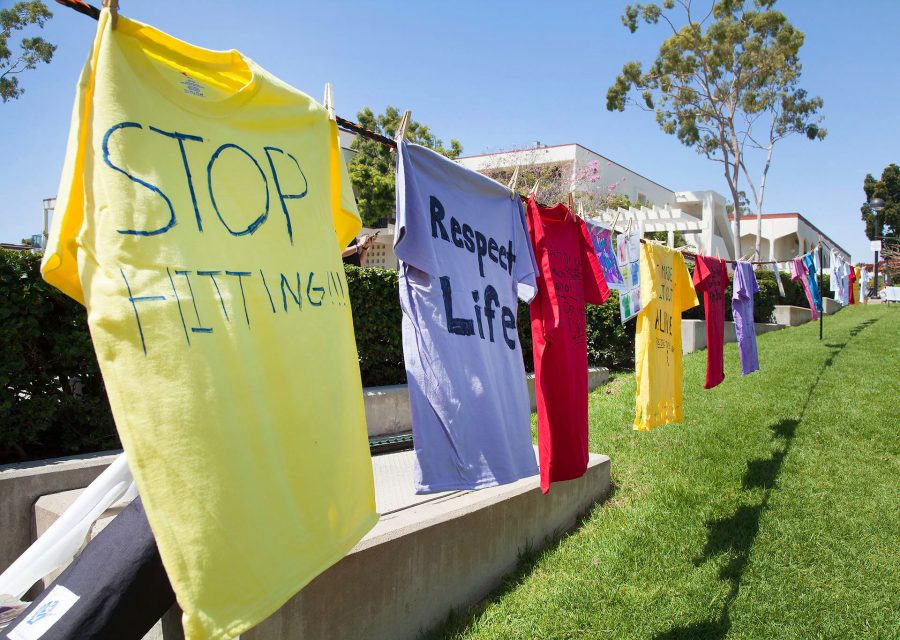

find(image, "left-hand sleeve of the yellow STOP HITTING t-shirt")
[41,53,96,304]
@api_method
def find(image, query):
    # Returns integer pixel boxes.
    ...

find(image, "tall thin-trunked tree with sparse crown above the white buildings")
[606,0,825,256]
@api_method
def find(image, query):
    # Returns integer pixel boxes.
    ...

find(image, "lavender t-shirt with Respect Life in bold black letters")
[394,142,538,493]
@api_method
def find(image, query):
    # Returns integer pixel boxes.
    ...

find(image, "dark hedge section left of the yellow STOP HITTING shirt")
[0,250,119,462]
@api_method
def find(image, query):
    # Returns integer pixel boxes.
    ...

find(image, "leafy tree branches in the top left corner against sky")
[0,0,56,102]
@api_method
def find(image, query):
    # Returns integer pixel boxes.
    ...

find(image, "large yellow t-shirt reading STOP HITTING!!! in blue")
[42,11,377,639]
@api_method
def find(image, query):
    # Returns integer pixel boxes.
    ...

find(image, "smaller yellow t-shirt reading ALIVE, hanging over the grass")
[634,243,698,431]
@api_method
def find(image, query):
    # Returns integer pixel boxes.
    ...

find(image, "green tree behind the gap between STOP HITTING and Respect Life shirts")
[348,107,462,226]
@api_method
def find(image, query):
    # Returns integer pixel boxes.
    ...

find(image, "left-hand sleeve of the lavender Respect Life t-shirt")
[394,141,438,276]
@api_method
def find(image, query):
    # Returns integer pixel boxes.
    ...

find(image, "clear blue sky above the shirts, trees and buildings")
[0,0,900,260]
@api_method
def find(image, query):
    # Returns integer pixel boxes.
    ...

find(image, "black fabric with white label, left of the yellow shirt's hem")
[3,498,175,640]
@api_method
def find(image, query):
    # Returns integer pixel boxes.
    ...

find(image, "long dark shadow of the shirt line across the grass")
[654,319,876,640]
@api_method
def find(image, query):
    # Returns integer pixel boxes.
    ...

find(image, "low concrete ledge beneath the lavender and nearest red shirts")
[241,454,610,640]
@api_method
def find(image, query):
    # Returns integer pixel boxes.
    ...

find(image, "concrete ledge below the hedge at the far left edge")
[0,451,120,571]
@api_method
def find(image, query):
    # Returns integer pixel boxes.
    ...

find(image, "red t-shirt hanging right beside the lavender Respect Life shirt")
[527,197,609,493]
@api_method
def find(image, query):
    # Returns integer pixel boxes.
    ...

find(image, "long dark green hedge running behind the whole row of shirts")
[0,250,828,463]
